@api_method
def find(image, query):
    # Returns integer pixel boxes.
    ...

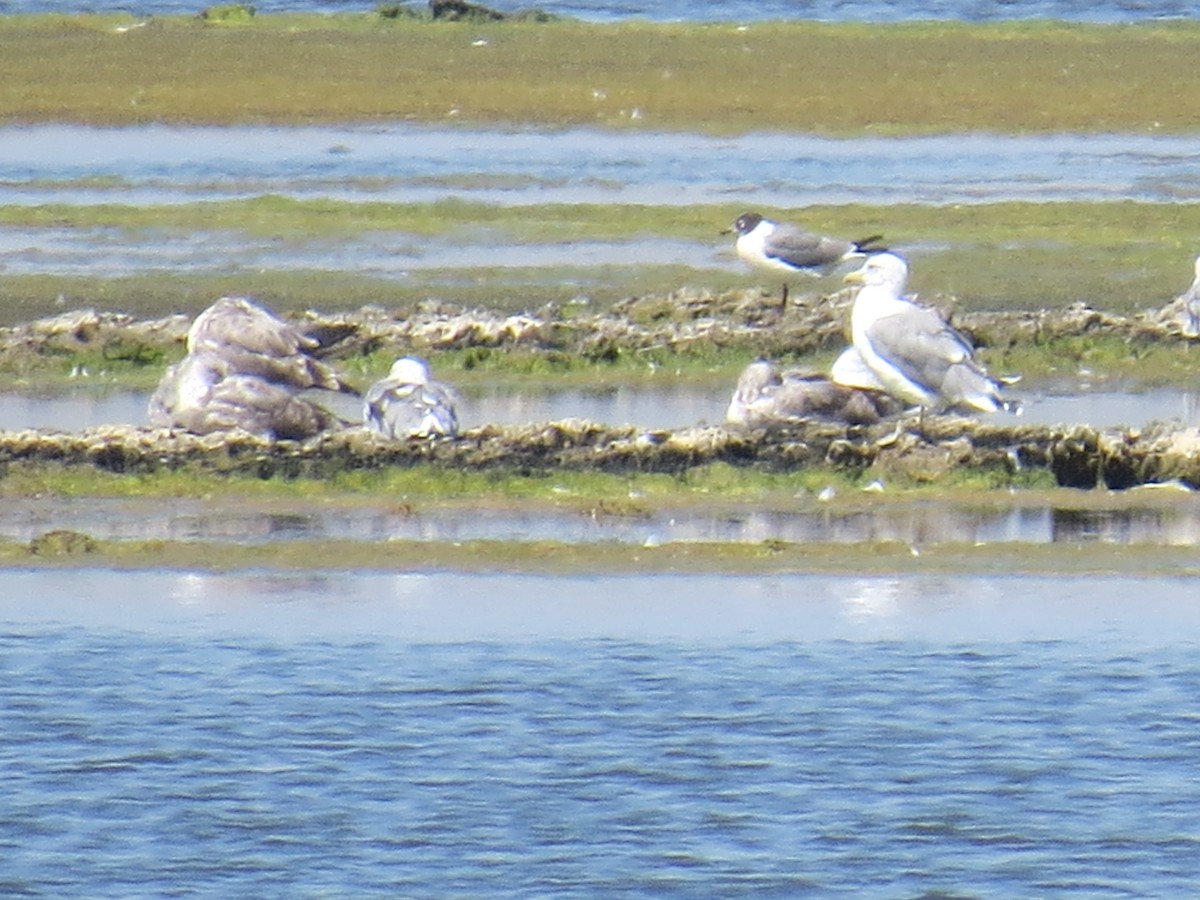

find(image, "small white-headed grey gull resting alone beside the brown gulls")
[362,356,458,438]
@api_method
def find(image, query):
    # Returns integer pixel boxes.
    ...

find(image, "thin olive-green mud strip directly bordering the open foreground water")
[0,532,1200,576]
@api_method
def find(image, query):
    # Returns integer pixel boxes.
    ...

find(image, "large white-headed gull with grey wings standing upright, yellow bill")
[845,253,1015,413]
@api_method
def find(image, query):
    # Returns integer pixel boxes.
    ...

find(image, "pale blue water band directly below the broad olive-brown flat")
[0,124,1200,212]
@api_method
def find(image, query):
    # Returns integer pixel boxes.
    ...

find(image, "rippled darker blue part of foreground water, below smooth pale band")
[0,609,1200,898]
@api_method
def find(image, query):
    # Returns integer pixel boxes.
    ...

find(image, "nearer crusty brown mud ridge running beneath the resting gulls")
[0,415,1200,488]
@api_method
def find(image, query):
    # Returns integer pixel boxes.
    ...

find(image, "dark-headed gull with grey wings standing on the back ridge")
[726,212,883,305]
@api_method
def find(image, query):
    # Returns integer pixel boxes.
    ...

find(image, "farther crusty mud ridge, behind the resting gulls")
[0,289,1181,359]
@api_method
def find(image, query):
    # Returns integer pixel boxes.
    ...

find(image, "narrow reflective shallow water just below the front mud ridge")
[7,487,1200,551]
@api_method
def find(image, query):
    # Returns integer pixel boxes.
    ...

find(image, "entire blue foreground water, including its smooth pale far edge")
[0,571,1200,898]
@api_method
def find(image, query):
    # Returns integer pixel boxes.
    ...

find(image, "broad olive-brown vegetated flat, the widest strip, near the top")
[0,12,1200,134]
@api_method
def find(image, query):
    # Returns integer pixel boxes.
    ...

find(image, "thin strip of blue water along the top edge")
[0,0,1200,22]
